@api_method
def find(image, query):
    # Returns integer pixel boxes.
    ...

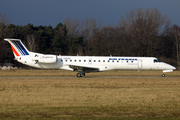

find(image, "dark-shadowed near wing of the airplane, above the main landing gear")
[69,65,99,72]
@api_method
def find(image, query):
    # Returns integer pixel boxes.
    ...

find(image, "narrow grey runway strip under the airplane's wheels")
[0,76,180,79]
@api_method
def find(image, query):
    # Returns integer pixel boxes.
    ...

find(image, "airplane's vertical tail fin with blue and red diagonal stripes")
[4,38,29,57]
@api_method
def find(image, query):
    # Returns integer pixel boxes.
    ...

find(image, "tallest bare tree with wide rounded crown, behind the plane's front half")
[119,8,170,56]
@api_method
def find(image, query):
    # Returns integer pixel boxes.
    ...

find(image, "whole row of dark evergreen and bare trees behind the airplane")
[0,8,180,66]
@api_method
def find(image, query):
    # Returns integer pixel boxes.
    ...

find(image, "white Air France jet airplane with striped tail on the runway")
[4,38,176,77]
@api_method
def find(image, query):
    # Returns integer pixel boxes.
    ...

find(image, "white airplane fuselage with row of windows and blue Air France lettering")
[17,52,175,72]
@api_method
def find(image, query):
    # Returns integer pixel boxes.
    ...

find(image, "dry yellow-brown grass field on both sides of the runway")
[0,70,180,120]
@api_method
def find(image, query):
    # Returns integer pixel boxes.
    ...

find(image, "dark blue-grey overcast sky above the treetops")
[0,0,180,27]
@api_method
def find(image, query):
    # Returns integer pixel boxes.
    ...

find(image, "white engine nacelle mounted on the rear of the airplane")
[32,55,57,63]
